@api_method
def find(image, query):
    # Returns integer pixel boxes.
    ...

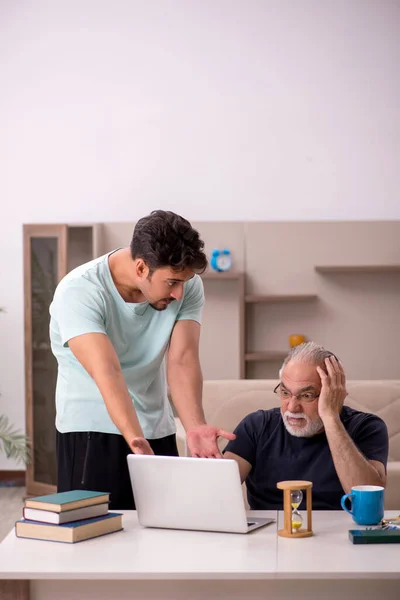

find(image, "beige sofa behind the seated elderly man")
[176,379,400,512]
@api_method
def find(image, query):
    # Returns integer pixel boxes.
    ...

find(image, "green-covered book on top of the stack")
[25,490,110,512]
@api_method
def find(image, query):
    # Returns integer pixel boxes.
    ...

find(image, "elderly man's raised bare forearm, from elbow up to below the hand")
[324,418,386,494]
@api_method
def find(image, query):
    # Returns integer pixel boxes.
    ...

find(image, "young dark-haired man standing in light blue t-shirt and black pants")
[50,210,234,509]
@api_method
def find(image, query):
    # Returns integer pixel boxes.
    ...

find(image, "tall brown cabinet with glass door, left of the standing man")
[24,224,94,495]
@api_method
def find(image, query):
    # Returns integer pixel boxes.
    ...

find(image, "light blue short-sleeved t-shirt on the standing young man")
[50,254,204,439]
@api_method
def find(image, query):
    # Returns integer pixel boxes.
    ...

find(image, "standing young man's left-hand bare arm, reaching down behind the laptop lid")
[68,333,153,454]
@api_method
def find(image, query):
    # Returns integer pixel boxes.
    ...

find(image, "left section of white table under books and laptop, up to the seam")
[0,511,277,579]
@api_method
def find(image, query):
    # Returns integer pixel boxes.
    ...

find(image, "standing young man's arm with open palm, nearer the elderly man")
[167,320,235,458]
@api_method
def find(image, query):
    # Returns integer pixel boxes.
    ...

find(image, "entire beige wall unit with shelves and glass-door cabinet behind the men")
[24,222,400,494]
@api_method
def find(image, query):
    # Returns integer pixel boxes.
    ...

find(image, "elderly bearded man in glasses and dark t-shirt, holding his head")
[224,342,388,510]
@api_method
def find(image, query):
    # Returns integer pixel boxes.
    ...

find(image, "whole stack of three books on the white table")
[15,490,122,544]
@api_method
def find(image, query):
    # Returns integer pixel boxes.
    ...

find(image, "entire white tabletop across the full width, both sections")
[0,511,400,580]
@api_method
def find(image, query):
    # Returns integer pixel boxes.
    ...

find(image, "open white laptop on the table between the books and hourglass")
[128,454,274,533]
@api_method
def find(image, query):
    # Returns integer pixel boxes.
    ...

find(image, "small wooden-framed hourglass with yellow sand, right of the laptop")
[277,481,313,537]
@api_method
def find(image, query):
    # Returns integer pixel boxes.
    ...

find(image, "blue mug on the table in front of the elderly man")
[340,485,385,525]
